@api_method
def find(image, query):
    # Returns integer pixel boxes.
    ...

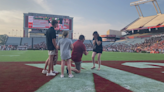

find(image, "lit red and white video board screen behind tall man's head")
[28,16,70,30]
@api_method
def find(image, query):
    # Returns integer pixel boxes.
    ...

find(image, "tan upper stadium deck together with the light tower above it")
[121,0,164,31]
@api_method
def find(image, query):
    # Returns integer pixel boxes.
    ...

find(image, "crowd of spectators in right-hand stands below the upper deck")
[107,37,164,52]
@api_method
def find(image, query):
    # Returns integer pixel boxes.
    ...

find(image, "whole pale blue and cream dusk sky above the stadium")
[0,0,164,39]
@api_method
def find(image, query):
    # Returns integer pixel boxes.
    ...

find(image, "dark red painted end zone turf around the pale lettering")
[0,61,164,92]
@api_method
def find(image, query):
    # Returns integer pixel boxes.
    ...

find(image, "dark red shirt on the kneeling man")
[72,40,86,62]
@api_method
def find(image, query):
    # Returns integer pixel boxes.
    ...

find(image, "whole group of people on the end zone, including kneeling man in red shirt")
[42,20,103,78]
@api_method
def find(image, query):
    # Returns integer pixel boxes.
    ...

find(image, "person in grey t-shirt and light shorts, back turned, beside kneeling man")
[57,31,74,78]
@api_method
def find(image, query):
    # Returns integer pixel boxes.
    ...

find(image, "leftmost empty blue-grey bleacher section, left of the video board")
[6,37,21,45]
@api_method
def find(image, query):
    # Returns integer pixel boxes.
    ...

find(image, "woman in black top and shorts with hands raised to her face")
[91,31,103,70]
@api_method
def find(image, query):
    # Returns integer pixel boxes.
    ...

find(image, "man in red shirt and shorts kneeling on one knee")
[68,35,88,73]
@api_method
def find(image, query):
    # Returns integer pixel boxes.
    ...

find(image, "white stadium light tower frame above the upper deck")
[130,0,162,17]
